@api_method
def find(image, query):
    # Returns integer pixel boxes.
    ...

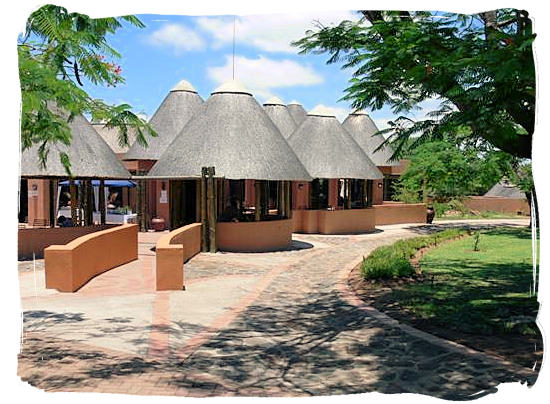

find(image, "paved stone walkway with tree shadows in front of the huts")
[18,219,537,399]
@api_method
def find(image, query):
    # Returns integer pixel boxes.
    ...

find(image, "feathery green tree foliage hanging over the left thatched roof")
[17,5,156,174]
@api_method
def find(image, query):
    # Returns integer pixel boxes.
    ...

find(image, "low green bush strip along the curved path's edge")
[361,229,466,279]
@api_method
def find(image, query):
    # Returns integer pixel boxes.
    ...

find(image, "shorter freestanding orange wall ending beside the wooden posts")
[155,223,202,290]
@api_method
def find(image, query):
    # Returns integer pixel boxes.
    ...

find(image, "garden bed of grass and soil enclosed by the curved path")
[348,228,542,367]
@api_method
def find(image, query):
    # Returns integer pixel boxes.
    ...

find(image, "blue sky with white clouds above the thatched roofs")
[86,11,435,128]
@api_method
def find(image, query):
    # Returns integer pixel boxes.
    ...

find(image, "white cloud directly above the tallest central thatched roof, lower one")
[207,55,323,99]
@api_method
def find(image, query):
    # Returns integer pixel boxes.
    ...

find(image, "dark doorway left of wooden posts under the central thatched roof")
[169,180,201,230]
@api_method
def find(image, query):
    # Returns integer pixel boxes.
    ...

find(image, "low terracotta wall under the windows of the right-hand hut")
[292,208,375,234]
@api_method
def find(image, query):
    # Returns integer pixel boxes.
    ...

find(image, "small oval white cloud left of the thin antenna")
[148,24,205,53]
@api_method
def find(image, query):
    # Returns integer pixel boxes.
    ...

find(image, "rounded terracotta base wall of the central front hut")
[216,219,292,252]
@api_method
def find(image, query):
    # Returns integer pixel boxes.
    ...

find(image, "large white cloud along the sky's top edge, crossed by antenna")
[197,11,359,53]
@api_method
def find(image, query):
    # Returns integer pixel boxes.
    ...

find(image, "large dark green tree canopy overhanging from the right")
[293,9,535,158]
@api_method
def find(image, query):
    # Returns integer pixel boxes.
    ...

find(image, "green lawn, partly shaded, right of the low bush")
[392,228,538,335]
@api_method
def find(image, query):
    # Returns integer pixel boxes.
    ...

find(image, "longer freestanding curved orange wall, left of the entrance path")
[44,224,138,292]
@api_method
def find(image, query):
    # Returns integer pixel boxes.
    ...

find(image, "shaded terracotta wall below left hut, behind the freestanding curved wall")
[17,224,118,260]
